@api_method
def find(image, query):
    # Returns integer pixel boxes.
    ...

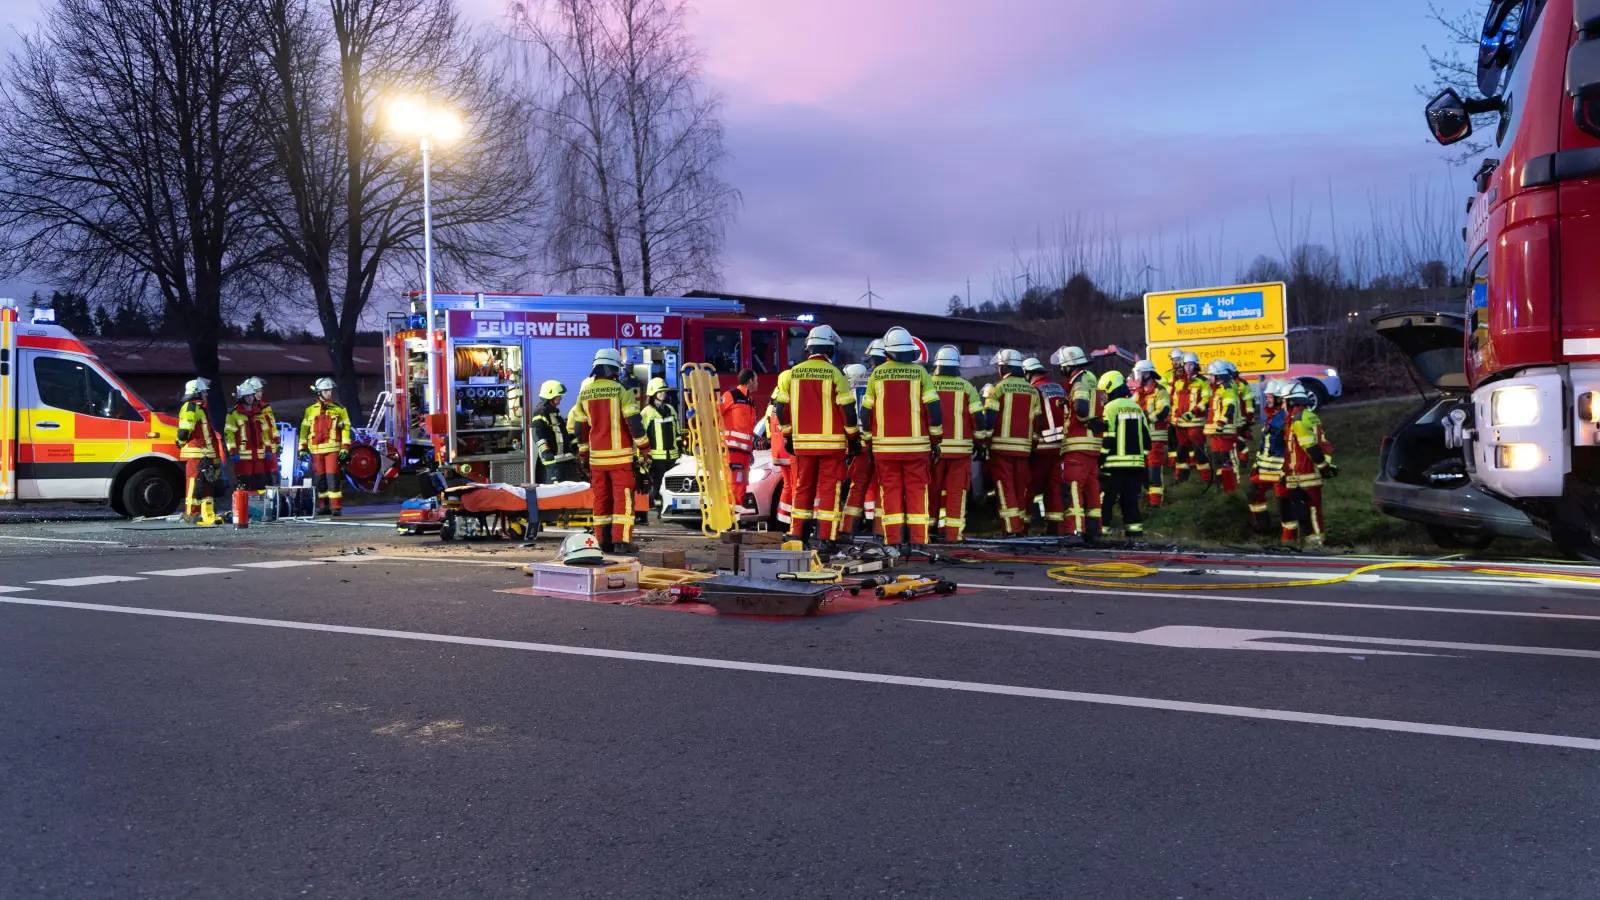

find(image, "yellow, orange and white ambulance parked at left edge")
[0,299,184,517]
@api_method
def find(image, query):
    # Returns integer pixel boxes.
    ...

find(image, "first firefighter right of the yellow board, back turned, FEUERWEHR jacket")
[773,325,861,549]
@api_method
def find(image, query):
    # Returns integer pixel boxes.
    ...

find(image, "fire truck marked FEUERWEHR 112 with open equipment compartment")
[371,293,808,484]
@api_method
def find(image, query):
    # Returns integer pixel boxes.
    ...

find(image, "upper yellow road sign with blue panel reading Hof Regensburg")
[1144,282,1288,344]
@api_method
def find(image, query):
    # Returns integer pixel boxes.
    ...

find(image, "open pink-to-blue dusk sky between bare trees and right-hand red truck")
[0,0,1467,311]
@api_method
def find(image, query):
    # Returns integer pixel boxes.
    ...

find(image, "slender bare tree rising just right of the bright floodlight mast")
[514,0,739,296]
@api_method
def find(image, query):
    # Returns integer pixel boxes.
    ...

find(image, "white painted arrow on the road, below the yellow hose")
[910,618,1600,660]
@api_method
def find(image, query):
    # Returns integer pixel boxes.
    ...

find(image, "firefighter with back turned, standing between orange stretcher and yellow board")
[566,348,650,552]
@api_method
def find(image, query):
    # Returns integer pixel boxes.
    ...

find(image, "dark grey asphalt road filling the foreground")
[0,522,1600,900]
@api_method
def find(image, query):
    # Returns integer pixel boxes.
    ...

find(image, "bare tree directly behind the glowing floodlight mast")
[254,0,541,407]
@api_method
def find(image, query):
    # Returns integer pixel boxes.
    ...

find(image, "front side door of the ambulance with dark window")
[18,349,137,500]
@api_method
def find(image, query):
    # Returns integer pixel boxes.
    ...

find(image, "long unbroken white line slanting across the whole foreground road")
[0,597,1600,751]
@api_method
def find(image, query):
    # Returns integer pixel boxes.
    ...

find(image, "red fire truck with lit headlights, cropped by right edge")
[1427,0,1600,556]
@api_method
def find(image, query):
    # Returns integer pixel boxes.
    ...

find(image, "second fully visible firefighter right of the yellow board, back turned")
[861,325,944,546]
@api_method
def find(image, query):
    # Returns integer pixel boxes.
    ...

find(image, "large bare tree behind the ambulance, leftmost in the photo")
[0,0,270,408]
